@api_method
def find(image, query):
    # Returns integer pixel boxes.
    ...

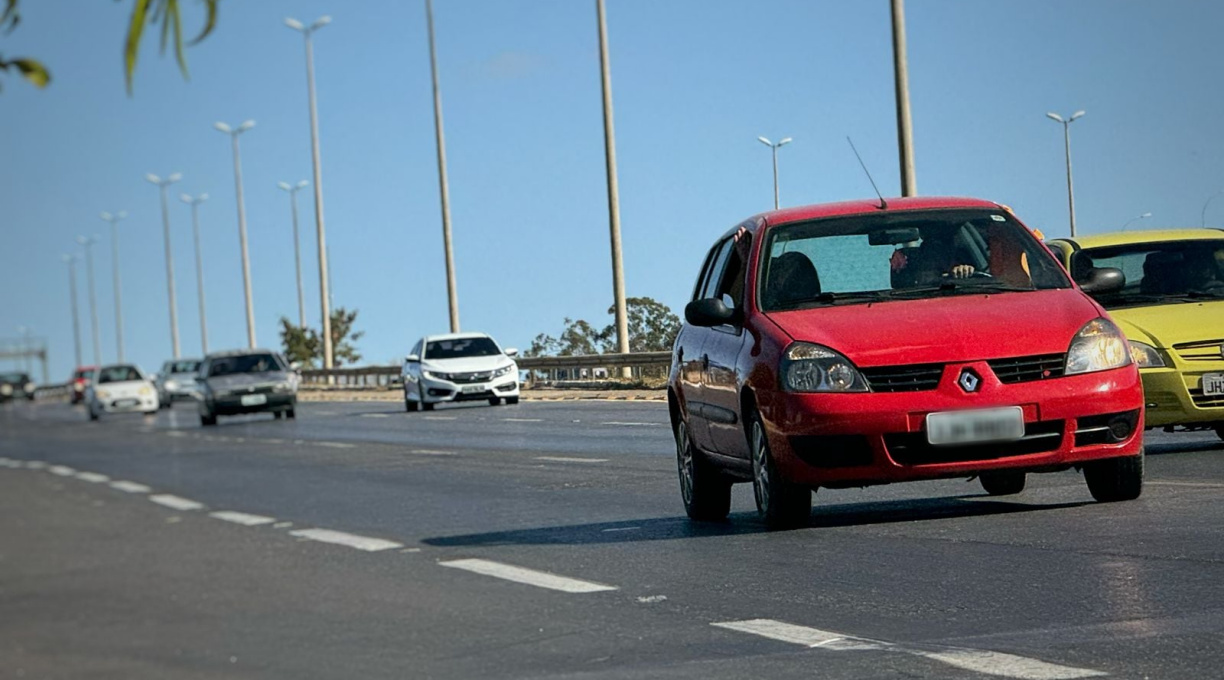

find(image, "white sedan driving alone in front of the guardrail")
[401,333,519,411]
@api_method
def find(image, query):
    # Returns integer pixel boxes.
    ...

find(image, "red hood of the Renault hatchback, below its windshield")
[766,289,1100,366]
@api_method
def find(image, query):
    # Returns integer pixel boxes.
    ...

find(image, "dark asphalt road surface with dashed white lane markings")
[0,402,1224,680]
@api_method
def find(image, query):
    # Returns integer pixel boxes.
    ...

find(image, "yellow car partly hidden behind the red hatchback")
[1048,229,1224,439]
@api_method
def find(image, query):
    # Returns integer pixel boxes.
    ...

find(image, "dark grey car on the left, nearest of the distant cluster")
[197,350,299,427]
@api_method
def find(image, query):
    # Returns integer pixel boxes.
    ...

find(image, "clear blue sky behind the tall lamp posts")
[0,0,1224,379]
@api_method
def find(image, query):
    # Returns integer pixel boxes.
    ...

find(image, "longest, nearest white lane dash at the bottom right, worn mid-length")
[710,619,1106,680]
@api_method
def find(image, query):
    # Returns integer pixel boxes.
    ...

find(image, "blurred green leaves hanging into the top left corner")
[0,0,220,95]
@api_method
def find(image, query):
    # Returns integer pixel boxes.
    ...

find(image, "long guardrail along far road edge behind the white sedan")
[301,352,672,388]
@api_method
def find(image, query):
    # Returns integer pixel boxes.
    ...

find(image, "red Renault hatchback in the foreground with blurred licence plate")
[667,198,1143,527]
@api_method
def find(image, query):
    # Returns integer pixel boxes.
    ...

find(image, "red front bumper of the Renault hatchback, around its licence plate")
[761,362,1143,487]
